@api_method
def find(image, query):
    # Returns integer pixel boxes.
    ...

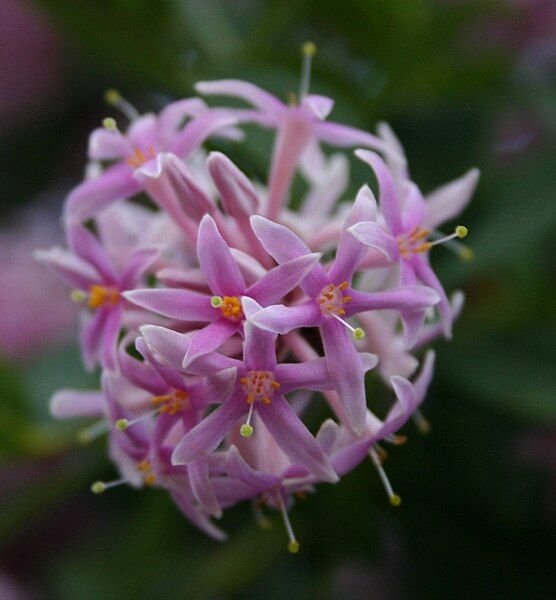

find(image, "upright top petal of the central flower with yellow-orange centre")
[197,215,245,296]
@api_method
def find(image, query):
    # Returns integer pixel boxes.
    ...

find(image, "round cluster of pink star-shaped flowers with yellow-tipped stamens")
[37,54,478,552]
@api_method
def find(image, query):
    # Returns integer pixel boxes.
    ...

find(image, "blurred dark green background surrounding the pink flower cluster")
[0,0,556,600]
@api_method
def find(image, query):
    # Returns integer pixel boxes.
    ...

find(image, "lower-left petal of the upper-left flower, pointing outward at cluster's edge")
[64,163,141,223]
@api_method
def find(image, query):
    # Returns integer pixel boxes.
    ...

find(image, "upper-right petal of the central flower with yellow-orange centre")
[246,253,321,306]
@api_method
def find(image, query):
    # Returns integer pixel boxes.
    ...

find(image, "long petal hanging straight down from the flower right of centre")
[320,319,367,433]
